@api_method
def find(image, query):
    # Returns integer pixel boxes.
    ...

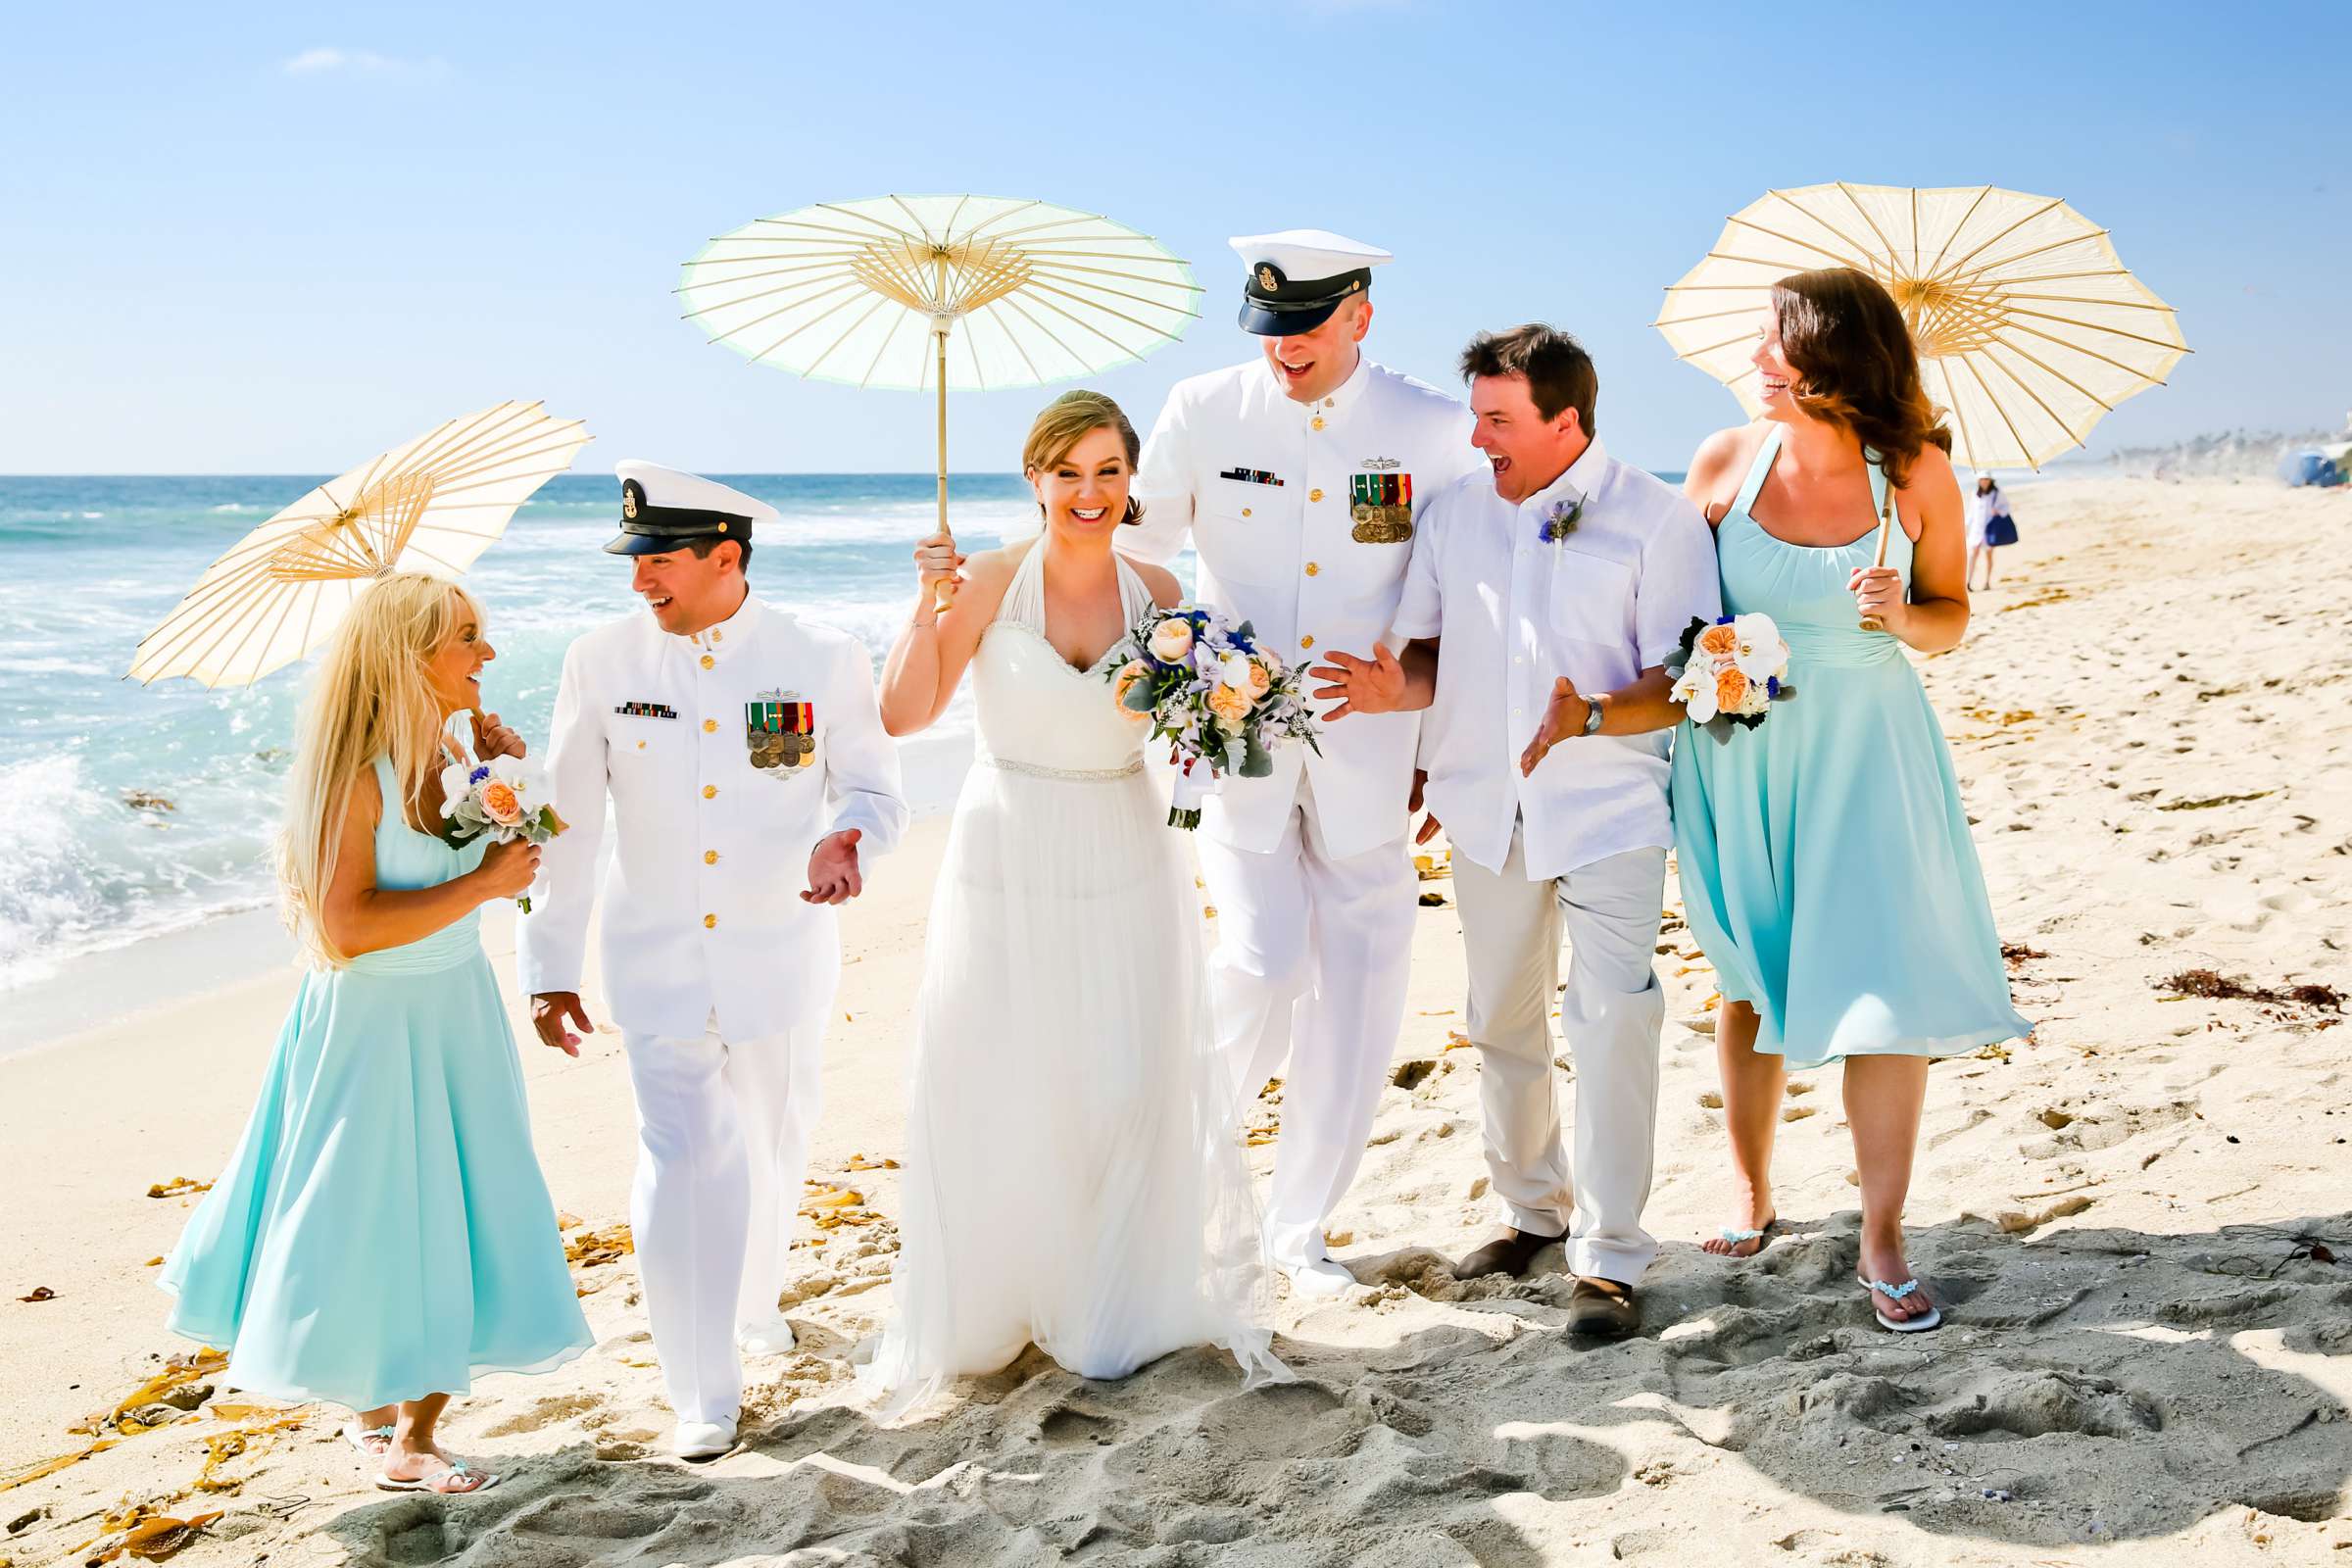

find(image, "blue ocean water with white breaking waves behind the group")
[0,475,1035,992]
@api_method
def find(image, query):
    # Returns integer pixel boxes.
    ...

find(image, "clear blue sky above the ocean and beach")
[0,0,2352,472]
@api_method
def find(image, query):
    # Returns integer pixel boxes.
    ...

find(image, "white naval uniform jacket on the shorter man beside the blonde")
[515,597,907,1039]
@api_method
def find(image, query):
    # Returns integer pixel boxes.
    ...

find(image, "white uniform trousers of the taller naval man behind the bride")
[1200,773,1416,1267]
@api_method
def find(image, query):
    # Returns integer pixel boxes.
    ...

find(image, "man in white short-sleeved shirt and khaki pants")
[1317,324,1719,1338]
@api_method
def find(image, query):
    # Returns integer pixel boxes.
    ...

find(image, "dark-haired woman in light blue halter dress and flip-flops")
[1675,268,2030,1333]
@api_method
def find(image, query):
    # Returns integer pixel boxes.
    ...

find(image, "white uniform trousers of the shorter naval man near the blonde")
[621,1022,825,1422]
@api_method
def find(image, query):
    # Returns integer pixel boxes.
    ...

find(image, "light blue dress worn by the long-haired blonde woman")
[160,757,595,1410]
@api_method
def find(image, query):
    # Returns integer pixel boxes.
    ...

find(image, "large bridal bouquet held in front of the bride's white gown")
[1105,602,1322,827]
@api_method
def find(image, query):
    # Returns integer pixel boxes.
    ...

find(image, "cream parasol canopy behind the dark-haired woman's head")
[1656,181,2189,470]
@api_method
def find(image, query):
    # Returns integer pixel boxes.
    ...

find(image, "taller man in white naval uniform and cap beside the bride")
[1119,228,1480,1296]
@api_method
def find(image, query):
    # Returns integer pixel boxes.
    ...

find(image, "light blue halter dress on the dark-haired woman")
[1672,428,2033,1067]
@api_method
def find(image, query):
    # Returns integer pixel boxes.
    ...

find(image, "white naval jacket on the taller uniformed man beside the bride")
[1117,360,1484,858]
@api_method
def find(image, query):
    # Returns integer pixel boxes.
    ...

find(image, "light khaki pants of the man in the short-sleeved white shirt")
[1453,830,1665,1286]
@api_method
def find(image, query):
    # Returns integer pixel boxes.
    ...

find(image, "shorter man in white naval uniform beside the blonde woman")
[515,464,907,1457]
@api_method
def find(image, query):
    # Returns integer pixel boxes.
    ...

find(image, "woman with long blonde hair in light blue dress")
[163,573,593,1495]
